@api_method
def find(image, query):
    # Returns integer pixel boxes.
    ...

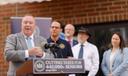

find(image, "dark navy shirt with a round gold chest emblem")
[47,38,73,58]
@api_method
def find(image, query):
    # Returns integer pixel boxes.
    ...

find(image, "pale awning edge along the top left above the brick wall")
[0,0,51,5]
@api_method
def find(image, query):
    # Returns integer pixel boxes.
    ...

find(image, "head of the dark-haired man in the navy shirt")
[50,21,62,37]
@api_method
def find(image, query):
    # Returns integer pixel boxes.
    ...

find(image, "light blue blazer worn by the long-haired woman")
[101,48,128,76]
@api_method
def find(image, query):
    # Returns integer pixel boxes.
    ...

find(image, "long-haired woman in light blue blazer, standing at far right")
[101,32,128,76]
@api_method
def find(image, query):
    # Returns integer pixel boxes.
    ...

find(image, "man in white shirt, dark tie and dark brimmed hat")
[72,28,99,76]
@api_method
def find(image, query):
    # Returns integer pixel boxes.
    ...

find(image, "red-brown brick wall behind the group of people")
[0,0,128,76]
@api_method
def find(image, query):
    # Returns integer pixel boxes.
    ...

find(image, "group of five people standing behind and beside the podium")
[4,15,128,76]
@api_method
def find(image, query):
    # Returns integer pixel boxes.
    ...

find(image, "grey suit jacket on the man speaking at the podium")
[4,33,54,76]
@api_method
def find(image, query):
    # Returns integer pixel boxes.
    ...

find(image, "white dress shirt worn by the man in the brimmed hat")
[72,42,99,76]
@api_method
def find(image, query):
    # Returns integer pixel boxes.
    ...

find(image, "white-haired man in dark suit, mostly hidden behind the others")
[64,24,78,47]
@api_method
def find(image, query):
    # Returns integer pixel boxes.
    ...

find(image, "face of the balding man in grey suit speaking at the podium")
[22,16,35,36]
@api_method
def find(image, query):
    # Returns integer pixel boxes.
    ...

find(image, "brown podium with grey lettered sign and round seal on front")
[16,59,85,76]
